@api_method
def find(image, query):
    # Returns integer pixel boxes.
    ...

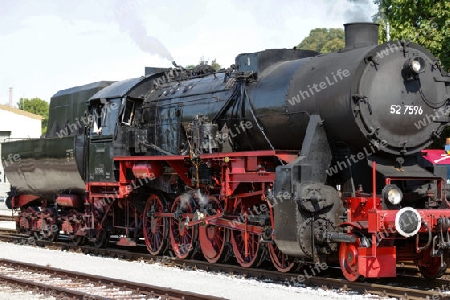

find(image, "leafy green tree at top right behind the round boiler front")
[374,0,450,70]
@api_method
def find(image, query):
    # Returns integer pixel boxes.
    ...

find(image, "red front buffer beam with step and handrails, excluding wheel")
[341,163,450,278]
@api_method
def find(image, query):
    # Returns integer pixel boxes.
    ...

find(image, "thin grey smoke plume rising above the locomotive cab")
[114,0,173,61]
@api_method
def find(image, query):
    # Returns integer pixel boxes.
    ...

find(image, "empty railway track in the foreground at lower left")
[0,259,222,300]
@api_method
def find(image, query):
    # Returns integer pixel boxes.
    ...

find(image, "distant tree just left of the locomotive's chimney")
[296,28,345,53]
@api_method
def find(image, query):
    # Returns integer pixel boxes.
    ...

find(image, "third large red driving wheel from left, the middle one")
[198,197,229,263]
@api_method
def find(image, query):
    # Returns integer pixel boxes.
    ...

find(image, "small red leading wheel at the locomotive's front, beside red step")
[339,238,361,281]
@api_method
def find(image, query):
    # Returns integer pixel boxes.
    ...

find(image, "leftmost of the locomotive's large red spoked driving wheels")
[143,194,169,255]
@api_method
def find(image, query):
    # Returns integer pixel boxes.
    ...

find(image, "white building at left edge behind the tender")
[0,105,42,207]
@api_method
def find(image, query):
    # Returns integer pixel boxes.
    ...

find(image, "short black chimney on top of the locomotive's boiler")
[344,23,379,49]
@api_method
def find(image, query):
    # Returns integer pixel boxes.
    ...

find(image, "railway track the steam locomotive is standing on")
[0,234,450,299]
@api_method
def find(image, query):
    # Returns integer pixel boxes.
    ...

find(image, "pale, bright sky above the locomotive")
[0,0,377,105]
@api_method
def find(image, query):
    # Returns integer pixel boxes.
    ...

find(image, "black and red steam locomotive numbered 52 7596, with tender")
[2,23,450,281]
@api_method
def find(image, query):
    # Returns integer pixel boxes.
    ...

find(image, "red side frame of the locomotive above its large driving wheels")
[112,150,298,236]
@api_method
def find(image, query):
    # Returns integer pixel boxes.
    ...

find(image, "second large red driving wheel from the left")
[169,197,198,259]
